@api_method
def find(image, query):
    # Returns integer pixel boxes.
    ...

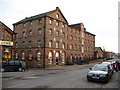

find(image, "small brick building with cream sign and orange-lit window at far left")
[0,21,15,61]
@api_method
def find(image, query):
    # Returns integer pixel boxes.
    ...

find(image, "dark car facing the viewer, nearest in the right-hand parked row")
[87,64,112,83]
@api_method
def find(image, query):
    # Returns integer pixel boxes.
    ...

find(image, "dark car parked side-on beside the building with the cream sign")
[1,60,26,72]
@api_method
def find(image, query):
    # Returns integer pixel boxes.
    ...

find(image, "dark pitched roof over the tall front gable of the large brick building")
[13,7,68,25]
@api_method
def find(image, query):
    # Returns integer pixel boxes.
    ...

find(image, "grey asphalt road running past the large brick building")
[2,59,120,89]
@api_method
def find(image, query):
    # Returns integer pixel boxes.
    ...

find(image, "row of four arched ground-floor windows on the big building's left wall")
[15,51,41,61]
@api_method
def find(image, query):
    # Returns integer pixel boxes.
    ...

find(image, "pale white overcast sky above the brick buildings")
[0,0,119,53]
